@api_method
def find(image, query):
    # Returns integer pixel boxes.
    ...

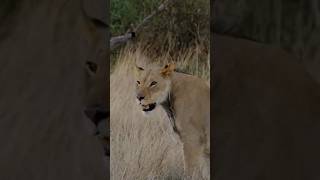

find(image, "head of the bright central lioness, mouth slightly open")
[135,63,175,114]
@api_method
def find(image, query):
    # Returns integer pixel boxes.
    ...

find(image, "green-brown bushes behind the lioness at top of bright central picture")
[111,0,210,51]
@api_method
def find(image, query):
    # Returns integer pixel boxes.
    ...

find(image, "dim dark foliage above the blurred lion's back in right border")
[213,0,320,82]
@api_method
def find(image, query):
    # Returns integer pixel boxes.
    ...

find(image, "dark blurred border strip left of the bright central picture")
[0,0,110,180]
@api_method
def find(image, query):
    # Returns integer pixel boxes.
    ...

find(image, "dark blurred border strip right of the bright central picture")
[210,0,320,180]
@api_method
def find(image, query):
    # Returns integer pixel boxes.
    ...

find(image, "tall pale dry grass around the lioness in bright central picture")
[110,44,210,180]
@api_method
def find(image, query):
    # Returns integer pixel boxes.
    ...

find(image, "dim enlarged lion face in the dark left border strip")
[84,51,110,157]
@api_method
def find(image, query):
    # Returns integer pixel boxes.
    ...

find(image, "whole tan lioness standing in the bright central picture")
[135,59,210,178]
